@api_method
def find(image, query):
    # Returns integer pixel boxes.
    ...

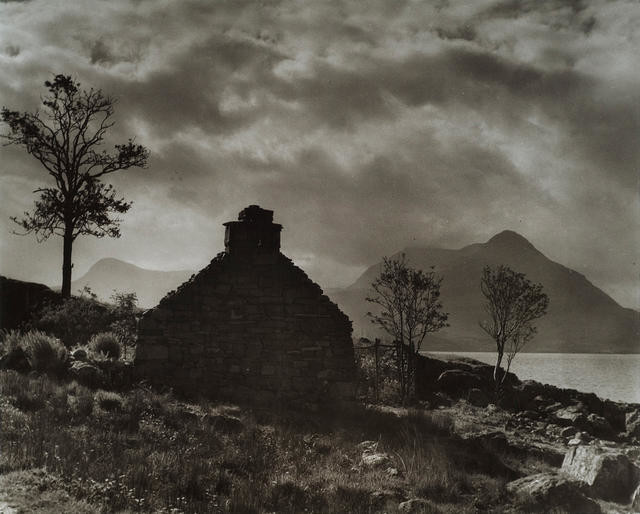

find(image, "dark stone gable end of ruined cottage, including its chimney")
[135,205,355,405]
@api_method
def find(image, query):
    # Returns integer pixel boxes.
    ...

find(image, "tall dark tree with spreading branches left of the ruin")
[0,75,149,298]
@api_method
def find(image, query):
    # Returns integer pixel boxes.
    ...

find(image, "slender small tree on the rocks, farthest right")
[480,265,549,389]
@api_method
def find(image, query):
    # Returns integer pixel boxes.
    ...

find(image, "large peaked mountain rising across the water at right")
[331,230,640,353]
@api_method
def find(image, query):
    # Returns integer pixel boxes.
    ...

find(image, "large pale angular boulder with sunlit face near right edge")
[561,445,640,503]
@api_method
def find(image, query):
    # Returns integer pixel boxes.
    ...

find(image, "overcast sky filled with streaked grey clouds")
[0,0,640,308]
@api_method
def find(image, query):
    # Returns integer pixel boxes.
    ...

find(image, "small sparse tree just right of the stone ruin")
[366,254,448,401]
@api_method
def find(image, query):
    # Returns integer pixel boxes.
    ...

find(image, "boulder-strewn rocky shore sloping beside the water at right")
[417,356,640,513]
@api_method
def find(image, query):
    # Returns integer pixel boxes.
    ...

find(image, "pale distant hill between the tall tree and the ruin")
[71,258,194,308]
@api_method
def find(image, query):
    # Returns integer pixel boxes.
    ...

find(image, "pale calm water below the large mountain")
[429,352,640,403]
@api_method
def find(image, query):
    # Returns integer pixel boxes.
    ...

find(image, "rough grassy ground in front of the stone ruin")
[0,371,548,513]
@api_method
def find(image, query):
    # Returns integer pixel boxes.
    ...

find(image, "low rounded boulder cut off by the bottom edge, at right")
[507,473,602,514]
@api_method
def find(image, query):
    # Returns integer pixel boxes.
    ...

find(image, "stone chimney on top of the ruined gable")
[224,205,282,256]
